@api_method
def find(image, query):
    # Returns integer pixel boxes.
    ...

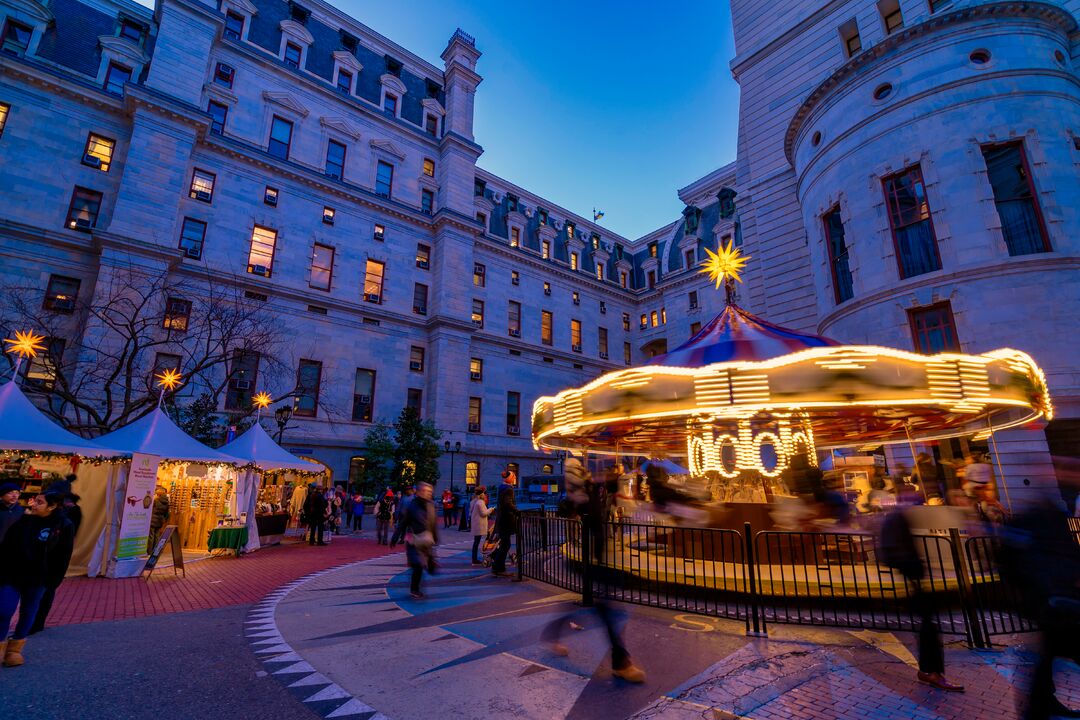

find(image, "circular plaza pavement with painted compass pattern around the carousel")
[246,544,1080,720]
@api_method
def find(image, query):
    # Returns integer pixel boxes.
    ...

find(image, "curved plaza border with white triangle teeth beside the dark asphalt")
[244,556,390,720]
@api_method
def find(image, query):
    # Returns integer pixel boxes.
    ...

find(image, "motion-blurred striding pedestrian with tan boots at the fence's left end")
[540,458,645,682]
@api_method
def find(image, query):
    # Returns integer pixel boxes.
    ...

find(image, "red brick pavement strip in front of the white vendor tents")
[48,535,389,627]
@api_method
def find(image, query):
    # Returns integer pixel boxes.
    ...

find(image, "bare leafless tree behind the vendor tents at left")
[0,264,288,436]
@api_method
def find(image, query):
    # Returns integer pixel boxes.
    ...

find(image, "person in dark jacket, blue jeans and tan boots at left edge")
[0,481,73,667]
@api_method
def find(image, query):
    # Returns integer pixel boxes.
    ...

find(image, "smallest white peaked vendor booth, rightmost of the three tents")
[221,422,323,552]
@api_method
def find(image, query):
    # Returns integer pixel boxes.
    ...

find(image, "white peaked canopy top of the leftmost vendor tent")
[0,380,123,458]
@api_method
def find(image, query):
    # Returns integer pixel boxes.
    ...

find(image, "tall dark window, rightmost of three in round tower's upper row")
[983,142,1050,255]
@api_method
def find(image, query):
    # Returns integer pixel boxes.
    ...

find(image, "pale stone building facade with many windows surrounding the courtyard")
[0,0,1080,505]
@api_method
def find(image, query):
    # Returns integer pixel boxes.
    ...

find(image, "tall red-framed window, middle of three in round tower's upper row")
[882,165,942,279]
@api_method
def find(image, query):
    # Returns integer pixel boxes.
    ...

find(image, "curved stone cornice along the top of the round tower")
[784,2,1076,165]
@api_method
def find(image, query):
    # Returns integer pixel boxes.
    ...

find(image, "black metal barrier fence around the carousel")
[517,513,1067,648]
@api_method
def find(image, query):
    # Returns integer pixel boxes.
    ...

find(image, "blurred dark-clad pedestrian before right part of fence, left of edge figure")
[881,488,963,692]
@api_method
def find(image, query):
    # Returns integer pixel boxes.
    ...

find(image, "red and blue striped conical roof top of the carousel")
[647,303,840,367]
